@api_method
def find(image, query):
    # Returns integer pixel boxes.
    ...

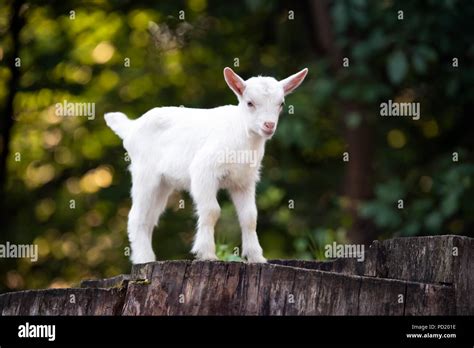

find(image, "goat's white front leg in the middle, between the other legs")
[191,176,221,260]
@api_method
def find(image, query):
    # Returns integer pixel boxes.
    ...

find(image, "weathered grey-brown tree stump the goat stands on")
[0,235,474,315]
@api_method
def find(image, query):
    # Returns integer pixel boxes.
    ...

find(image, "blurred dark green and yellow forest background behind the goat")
[0,0,474,292]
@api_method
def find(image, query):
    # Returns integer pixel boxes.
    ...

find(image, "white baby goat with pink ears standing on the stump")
[105,68,308,264]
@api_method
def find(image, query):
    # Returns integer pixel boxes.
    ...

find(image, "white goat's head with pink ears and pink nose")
[224,68,308,138]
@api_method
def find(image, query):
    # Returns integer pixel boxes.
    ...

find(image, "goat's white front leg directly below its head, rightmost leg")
[230,184,267,263]
